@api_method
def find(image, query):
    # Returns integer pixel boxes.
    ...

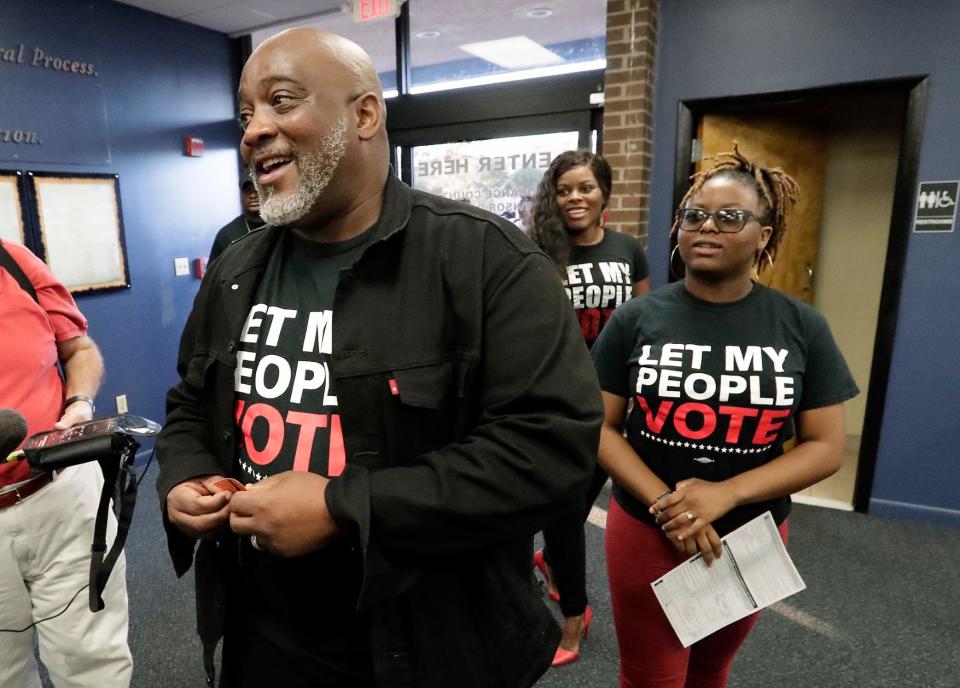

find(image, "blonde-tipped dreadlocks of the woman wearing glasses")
[671,141,800,272]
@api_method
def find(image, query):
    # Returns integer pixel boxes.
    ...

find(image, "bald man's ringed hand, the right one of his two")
[230,471,338,557]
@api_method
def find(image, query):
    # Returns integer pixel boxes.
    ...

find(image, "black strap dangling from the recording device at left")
[90,437,140,612]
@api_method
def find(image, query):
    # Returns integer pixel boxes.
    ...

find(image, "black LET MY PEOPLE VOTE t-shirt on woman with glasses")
[593,282,858,535]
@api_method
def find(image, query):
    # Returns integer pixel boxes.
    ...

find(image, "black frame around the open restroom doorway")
[671,76,929,513]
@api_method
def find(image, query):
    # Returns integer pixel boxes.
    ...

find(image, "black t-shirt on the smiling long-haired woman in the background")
[563,229,650,347]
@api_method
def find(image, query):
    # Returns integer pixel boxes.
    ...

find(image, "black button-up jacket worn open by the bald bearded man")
[157,176,602,688]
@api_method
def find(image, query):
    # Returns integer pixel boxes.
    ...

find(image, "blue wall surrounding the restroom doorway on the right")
[649,0,960,523]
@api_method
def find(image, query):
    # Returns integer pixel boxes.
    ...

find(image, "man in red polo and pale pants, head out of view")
[0,242,133,688]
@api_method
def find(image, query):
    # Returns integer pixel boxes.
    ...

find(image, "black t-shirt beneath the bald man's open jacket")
[228,230,372,686]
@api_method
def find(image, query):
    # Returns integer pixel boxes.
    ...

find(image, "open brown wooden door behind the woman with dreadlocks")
[696,112,827,304]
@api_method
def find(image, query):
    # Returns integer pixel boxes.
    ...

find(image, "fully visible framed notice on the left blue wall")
[27,172,130,293]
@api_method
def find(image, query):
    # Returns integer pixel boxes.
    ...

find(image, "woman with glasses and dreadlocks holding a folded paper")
[593,144,858,688]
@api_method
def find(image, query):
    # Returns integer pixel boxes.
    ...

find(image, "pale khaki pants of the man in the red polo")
[0,462,133,688]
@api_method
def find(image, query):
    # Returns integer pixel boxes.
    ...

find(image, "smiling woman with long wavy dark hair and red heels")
[530,151,649,666]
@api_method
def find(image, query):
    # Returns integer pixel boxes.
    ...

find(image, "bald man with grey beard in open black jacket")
[157,29,602,688]
